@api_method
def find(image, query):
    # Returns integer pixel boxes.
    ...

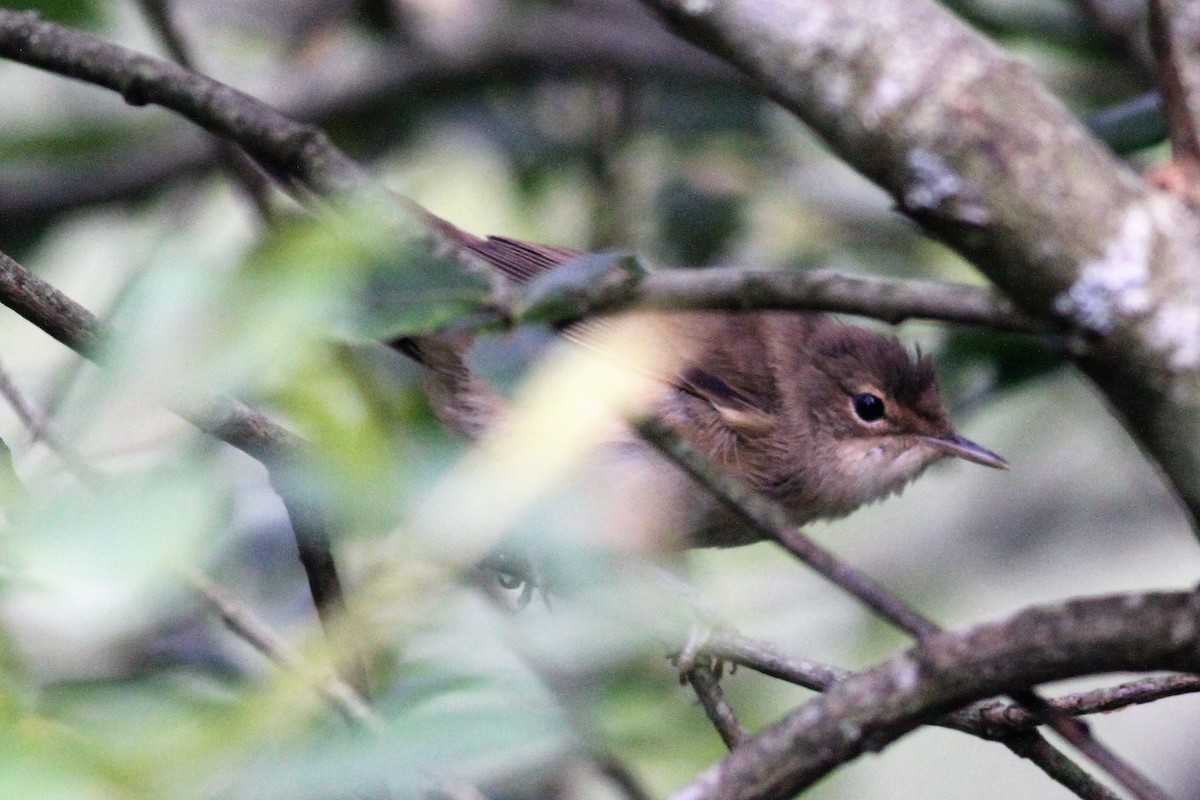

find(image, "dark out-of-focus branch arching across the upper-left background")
[0,6,749,224]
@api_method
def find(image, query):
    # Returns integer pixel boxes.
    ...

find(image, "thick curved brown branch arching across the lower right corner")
[673,593,1200,800]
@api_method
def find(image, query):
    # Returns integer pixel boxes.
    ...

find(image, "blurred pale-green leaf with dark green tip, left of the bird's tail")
[108,201,488,397]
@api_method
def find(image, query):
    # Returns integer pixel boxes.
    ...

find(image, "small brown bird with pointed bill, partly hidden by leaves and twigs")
[394,219,1008,547]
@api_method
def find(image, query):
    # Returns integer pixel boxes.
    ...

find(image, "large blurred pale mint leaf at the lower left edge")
[4,459,221,662]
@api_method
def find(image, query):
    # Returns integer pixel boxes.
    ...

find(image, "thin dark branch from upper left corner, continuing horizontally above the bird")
[0,10,1032,340]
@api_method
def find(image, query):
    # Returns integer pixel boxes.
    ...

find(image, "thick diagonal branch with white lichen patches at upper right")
[646,0,1200,542]
